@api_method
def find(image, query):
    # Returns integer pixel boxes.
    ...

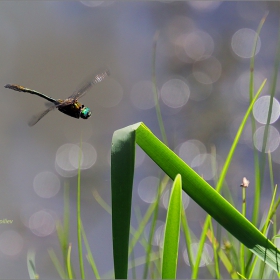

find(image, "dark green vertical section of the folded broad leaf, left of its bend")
[111,126,137,279]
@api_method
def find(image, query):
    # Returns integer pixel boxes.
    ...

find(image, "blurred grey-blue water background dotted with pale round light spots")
[0,1,280,279]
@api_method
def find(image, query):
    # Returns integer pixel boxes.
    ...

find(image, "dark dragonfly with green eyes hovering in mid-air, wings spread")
[5,69,110,126]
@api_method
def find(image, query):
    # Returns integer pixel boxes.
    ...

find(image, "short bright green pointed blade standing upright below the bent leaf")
[162,174,182,279]
